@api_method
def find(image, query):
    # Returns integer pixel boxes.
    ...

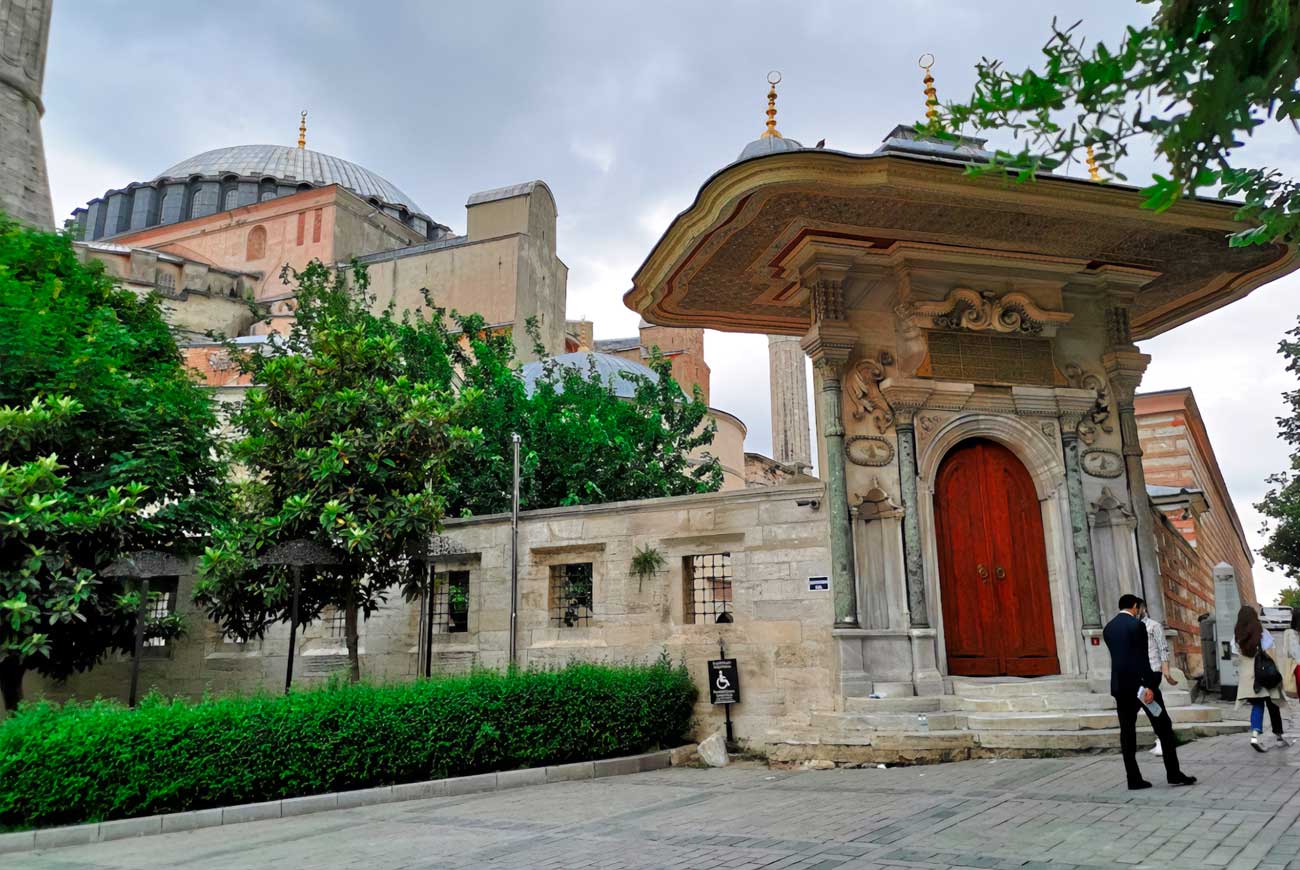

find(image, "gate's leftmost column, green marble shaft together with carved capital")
[801,281,858,628]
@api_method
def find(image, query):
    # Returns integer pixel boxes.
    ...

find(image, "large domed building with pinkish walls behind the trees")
[72,113,810,489]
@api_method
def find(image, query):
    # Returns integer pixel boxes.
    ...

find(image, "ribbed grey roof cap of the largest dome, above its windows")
[155,146,424,215]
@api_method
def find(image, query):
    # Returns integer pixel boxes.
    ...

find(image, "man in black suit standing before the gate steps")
[1102,594,1196,789]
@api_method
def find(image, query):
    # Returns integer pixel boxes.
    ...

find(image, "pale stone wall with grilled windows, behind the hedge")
[26,484,837,743]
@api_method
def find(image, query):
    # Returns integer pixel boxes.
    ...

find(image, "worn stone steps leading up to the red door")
[768,678,1244,763]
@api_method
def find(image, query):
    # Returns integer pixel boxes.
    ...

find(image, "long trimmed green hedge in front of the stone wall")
[0,661,697,830]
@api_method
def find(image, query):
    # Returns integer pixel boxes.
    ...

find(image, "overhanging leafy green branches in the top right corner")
[922,0,1300,244]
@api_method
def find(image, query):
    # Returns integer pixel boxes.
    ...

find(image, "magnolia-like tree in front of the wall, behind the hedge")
[195,261,477,681]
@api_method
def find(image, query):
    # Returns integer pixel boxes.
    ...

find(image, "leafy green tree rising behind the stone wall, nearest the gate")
[434,315,723,515]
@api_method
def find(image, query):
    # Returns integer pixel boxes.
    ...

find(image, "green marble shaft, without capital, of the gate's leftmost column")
[818,363,858,628]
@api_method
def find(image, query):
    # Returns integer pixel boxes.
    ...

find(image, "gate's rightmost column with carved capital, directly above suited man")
[1101,308,1165,623]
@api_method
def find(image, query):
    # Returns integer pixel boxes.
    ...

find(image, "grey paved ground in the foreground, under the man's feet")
[10,736,1300,870]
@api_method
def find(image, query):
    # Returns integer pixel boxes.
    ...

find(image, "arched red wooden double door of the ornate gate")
[935,438,1060,676]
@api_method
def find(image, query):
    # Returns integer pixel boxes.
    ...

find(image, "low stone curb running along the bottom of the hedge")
[0,748,689,854]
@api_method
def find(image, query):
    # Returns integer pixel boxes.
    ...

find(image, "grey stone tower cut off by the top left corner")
[0,0,55,228]
